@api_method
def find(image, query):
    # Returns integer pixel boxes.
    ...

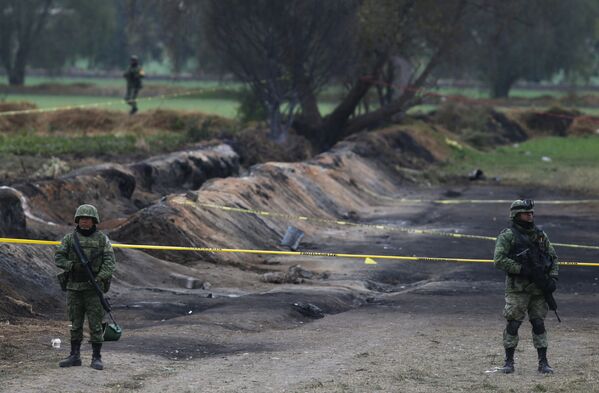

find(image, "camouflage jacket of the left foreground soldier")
[54,231,116,291]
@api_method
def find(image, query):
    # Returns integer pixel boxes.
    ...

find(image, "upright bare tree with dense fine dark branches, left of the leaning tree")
[203,0,357,141]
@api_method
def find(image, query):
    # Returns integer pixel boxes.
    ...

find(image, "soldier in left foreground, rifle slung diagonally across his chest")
[54,205,116,370]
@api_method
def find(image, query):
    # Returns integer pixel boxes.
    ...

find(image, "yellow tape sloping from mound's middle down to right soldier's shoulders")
[171,196,599,250]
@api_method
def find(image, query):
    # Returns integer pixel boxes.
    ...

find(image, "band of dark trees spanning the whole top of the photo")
[0,0,599,147]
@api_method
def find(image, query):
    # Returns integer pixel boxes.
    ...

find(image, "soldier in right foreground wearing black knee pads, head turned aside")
[494,200,558,374]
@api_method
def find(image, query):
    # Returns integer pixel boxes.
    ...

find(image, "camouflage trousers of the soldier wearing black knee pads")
[503,292,548,348]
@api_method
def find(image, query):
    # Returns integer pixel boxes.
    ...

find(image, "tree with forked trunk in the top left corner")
[0,0,53,86]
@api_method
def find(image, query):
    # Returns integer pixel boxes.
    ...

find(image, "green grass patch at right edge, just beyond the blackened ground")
[434,135,599,192]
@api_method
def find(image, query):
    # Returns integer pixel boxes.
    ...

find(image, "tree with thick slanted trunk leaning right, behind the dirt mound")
[294,0,467,148]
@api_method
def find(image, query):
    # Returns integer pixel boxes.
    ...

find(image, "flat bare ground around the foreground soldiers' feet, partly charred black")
[0,185,599,392]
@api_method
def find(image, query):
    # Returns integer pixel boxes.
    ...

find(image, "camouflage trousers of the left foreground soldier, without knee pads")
[67,289,104,343]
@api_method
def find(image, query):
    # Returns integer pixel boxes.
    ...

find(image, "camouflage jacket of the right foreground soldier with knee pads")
[493,222,559,295]
